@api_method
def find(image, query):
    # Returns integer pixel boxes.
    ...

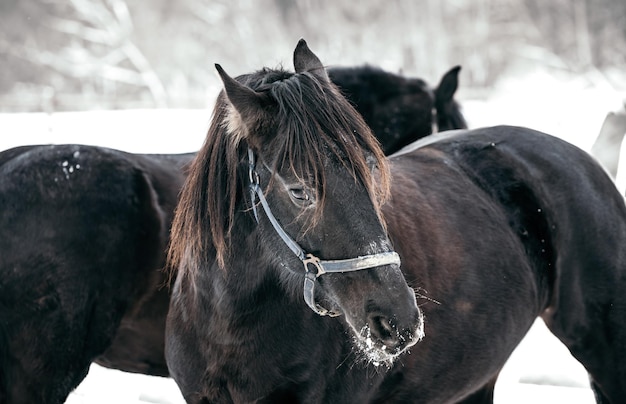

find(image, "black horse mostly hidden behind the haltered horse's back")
[328,66,467,155]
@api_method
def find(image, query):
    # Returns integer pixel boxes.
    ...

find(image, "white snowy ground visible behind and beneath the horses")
[0,72,626,404]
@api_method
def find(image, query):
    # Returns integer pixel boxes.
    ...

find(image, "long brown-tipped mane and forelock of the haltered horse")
[168,68,389,278]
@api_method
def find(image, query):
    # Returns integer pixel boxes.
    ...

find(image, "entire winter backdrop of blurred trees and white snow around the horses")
[0,0,626,404]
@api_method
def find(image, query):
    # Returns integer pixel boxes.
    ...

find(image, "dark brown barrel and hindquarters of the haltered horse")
[372,127,626,402]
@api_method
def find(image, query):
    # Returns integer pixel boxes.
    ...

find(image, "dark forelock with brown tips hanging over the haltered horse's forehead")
[270,72,388,214]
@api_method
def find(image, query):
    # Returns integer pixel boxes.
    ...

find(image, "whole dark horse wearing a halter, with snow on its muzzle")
[166,41,626,403]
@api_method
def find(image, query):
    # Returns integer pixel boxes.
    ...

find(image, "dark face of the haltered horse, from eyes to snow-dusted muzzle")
[267,156,423,365]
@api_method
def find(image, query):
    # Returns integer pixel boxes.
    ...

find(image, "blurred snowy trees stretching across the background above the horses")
[0,0,626,110]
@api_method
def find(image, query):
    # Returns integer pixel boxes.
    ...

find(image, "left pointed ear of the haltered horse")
[215,63,267,137]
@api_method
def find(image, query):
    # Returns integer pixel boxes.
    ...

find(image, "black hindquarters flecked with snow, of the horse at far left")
[0,145,192,403]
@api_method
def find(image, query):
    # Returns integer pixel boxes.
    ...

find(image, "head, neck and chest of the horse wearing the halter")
[166,41,423,403]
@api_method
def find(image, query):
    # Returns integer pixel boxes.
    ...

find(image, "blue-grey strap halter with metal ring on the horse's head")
[248,149,400,317]
